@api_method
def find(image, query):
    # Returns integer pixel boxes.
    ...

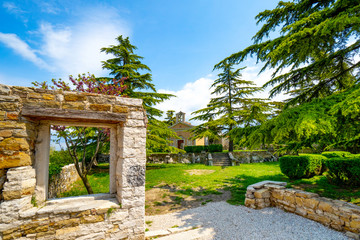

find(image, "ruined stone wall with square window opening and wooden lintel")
[0,85,146,240]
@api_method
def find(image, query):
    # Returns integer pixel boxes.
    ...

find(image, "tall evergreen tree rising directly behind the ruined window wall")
[101,36,177,152]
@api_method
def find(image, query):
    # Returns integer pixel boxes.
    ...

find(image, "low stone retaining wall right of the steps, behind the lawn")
[232,151,278,163]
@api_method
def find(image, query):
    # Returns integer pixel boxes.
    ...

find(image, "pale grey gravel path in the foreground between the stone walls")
[146,202,349,240]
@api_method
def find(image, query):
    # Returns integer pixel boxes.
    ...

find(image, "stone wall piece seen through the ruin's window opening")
[48,164,80,199]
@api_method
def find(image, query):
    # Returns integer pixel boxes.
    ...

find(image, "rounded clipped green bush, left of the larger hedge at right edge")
[279,154,326,179]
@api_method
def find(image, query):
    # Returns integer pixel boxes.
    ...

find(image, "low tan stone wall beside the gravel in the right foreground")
[245,181,360,239]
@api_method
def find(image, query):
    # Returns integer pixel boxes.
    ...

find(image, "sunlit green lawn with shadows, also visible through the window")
[57,162,360,205]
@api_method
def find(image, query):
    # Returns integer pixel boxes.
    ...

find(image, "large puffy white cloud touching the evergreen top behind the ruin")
[39,7,129,76]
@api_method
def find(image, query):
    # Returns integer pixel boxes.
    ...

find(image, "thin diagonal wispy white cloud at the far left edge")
[0,32,50,70]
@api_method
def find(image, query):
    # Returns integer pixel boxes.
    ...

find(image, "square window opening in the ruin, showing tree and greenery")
[47,125,110,200]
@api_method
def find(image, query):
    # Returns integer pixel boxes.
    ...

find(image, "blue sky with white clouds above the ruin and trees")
[0,0,278,120]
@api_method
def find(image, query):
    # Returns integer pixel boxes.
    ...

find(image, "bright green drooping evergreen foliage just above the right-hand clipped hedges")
[246,84,360,152]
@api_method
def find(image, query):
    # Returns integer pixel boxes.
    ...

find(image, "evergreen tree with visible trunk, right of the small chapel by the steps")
[192,62,260,151]
